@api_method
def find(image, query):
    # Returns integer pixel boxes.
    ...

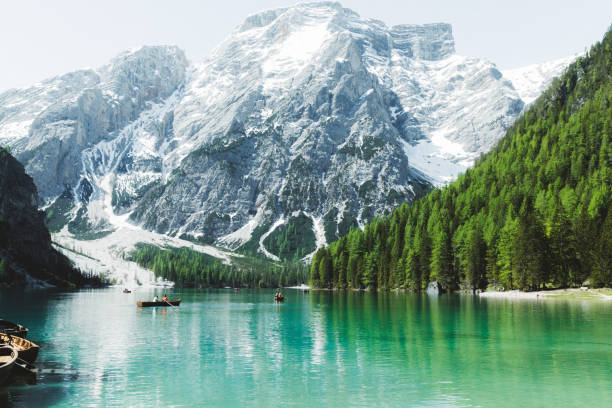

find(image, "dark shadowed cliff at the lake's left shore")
[0,148,81,286]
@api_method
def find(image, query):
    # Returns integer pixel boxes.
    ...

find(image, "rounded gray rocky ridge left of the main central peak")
[0,47,187,198]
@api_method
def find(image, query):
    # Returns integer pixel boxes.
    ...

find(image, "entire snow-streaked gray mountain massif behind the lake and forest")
[0,2,569,257]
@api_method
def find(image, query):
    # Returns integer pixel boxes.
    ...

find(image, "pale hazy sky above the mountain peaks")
[0,0,612,91]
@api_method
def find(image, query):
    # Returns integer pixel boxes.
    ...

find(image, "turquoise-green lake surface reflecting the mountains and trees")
[0,288,612,407]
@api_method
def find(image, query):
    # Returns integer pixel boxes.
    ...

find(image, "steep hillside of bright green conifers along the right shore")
[311,27,612,290]
